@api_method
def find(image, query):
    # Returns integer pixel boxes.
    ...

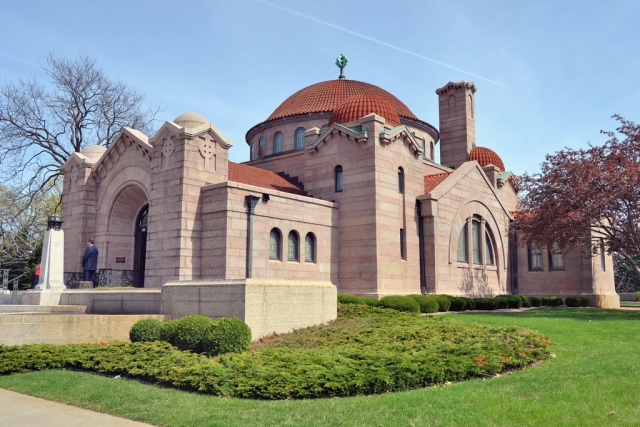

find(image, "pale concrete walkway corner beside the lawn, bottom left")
[0,388,151,427]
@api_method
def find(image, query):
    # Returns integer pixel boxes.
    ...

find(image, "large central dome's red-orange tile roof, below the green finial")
[266,79,419,122]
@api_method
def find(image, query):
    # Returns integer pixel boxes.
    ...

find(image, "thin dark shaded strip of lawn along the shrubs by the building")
[460,307,640,322]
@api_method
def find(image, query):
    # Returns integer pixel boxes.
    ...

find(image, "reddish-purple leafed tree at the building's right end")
[515,115,640,275]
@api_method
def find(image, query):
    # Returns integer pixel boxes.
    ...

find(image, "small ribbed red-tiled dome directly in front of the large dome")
[329,93,400,126]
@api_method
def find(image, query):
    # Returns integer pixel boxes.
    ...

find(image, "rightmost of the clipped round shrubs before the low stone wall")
[202,317,251,356]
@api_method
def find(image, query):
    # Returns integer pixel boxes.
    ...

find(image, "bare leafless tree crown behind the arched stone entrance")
[0,54,158,194]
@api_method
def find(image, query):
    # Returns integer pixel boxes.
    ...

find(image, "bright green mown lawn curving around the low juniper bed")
[0,308,640,426]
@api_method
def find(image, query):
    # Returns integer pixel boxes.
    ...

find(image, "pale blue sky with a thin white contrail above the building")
[0,0,640,174]
